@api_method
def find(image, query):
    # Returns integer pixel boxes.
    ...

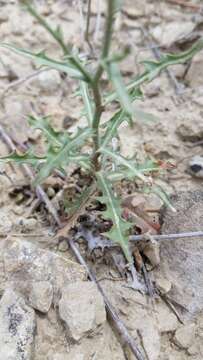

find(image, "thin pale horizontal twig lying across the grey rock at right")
[129,231,203,242]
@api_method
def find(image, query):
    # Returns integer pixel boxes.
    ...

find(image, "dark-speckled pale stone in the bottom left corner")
[0,289,35,360]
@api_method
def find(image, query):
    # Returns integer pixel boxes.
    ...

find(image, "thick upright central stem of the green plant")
[91,0,115,170]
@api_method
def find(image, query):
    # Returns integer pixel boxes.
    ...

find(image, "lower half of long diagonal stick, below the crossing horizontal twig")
[67,239,144,360]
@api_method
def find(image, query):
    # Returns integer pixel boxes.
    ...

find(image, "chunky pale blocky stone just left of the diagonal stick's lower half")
[59,281,106,341]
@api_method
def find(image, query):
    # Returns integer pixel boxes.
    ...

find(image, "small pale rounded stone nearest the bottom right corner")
[174,324,195,349]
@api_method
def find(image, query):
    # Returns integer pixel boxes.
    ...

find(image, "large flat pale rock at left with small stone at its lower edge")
[3,239,85,312]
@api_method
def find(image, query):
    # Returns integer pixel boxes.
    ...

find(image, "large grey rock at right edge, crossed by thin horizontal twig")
[157,191,203,318]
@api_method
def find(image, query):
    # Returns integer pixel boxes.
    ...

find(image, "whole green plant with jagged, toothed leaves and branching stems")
[0,0,203,263]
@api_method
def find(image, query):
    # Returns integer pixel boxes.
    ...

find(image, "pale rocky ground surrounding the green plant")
[0,0,203,360]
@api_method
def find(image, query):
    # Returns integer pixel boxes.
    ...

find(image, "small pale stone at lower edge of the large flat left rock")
[29,281,53,313]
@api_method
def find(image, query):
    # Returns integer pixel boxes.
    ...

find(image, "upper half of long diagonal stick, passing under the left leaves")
[0,125,61,227]
